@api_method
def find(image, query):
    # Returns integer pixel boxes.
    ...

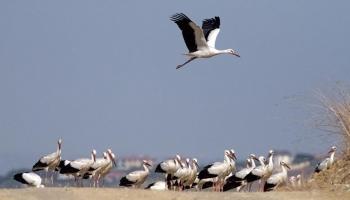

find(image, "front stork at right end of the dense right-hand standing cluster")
[264,162,290,192]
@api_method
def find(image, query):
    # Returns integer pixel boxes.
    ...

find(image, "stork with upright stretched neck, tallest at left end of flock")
[32,139,62,183]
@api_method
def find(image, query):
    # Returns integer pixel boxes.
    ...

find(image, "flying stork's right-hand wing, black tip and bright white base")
[202,16,220,48]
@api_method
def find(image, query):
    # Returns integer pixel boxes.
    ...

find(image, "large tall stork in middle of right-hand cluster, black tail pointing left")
[198,150,236,191]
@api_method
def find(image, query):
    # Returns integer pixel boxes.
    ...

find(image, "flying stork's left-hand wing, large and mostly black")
[170,13,208,53]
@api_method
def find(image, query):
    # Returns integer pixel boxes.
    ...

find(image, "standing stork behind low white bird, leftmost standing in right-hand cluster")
[155,154,183,189]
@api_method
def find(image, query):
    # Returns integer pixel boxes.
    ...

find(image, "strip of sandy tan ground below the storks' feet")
[0,188,350,200]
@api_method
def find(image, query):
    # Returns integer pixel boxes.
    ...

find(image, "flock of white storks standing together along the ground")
[14,139,336,192]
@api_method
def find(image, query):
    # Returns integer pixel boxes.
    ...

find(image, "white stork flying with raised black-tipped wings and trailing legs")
[170,13,240,69]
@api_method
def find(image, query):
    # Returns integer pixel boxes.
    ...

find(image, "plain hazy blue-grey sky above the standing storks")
[0,0,350,173]
